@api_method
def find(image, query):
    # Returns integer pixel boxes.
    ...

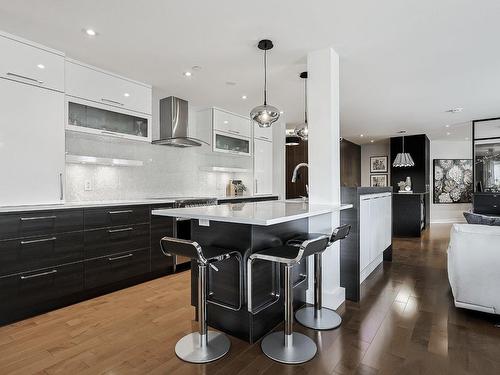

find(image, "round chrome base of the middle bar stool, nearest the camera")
[260,331,318,365]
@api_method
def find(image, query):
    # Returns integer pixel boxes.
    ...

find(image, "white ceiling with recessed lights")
[0,0,500,143]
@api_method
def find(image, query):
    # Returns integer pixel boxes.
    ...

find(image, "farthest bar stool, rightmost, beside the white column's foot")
[287,224,351,330]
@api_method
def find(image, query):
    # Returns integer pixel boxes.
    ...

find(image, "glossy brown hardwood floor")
[0,225,500,375]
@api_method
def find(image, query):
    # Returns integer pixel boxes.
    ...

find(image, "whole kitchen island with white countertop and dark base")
[152,201,352,342]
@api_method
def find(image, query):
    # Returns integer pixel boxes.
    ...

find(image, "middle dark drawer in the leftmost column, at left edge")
[0,232,83,276]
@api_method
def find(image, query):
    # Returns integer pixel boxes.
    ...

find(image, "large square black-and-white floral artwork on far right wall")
[433,159,473,204]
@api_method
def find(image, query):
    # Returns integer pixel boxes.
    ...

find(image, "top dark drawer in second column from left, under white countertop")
[84,206,149,230]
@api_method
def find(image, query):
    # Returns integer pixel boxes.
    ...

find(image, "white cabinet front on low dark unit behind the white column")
[359,193,392,283]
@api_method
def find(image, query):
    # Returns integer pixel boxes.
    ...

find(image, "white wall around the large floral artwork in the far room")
[430,140,472,223]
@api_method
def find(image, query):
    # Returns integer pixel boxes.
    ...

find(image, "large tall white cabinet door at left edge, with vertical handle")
[0,79,65,206]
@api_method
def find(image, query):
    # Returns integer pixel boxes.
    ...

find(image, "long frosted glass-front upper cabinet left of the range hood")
[66,101,151,142]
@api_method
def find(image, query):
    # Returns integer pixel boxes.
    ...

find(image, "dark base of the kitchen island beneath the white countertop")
[191,219,308,343]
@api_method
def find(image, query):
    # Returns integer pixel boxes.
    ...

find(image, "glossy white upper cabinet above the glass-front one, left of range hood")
[66,60,152,115]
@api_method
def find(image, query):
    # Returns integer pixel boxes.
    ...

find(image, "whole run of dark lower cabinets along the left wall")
[0,205,175,324]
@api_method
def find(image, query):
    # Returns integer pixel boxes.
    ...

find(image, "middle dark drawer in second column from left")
[84,224,149,259]
